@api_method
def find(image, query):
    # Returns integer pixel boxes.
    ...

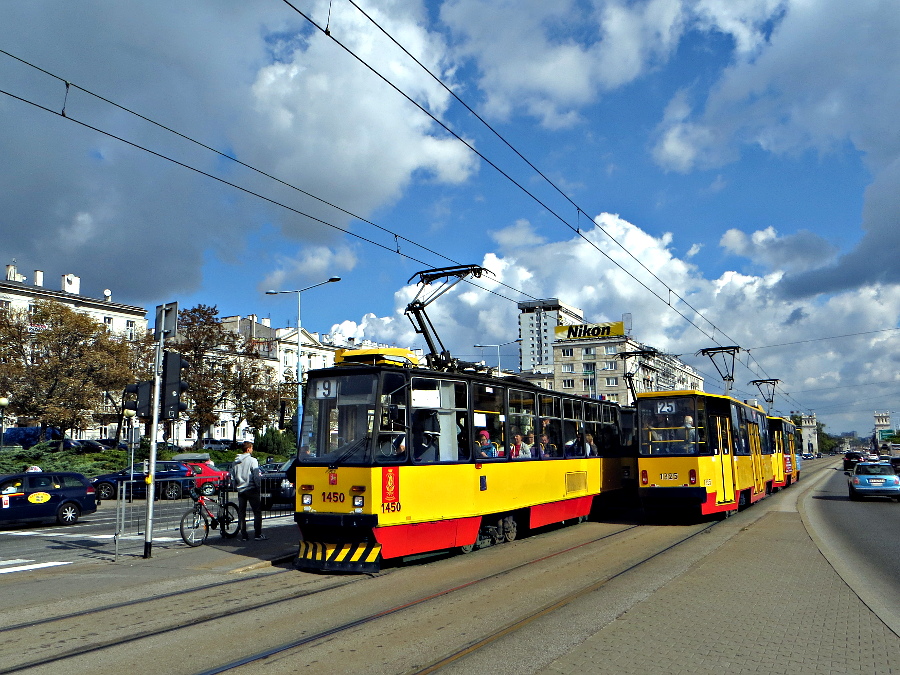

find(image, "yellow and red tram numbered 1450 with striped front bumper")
[295,355,636,571]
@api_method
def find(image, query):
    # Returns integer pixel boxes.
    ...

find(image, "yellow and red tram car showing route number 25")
[637,391,775,514]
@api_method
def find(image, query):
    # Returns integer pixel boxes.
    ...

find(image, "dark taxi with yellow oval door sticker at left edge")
[0,471,97,525]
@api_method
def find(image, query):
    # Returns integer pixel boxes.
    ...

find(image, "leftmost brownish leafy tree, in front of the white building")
[0,301,132,440]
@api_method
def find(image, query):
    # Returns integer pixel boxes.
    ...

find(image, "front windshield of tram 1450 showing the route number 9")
[298,373,378,464]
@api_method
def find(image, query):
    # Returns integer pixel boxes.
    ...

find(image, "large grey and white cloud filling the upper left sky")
[0,0,477,303]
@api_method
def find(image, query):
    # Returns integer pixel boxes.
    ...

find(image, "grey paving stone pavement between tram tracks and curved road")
[541,511,900,675]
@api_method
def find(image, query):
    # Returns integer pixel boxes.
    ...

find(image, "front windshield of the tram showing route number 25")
[638,397,705,455]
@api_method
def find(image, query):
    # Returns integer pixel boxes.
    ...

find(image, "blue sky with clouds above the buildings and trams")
[0,0,900,433]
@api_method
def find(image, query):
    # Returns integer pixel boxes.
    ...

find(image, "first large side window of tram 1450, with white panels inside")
[407,377,469,463]
